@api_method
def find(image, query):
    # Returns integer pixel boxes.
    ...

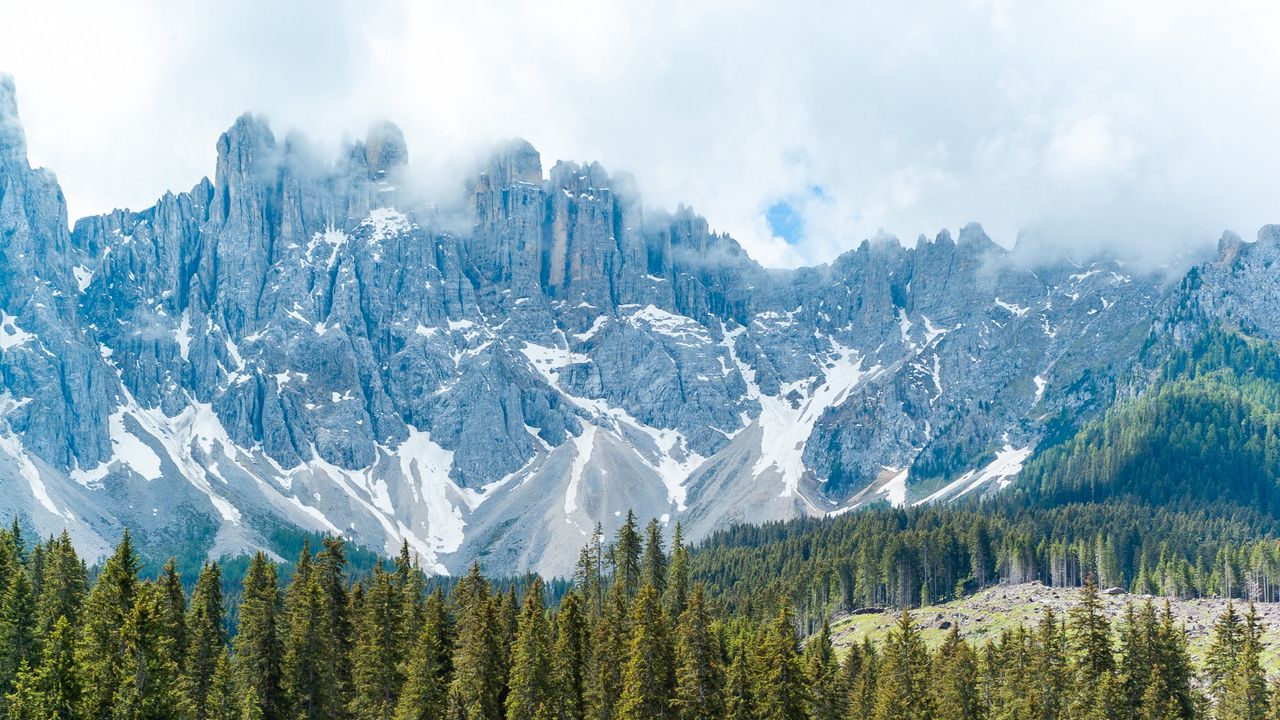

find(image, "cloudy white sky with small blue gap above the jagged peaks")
[0,0,1280,265]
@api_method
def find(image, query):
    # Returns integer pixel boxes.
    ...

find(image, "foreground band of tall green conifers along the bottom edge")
[0,507,1280,720]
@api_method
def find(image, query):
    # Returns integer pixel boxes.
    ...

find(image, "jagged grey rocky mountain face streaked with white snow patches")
[0,78,1259,573]
